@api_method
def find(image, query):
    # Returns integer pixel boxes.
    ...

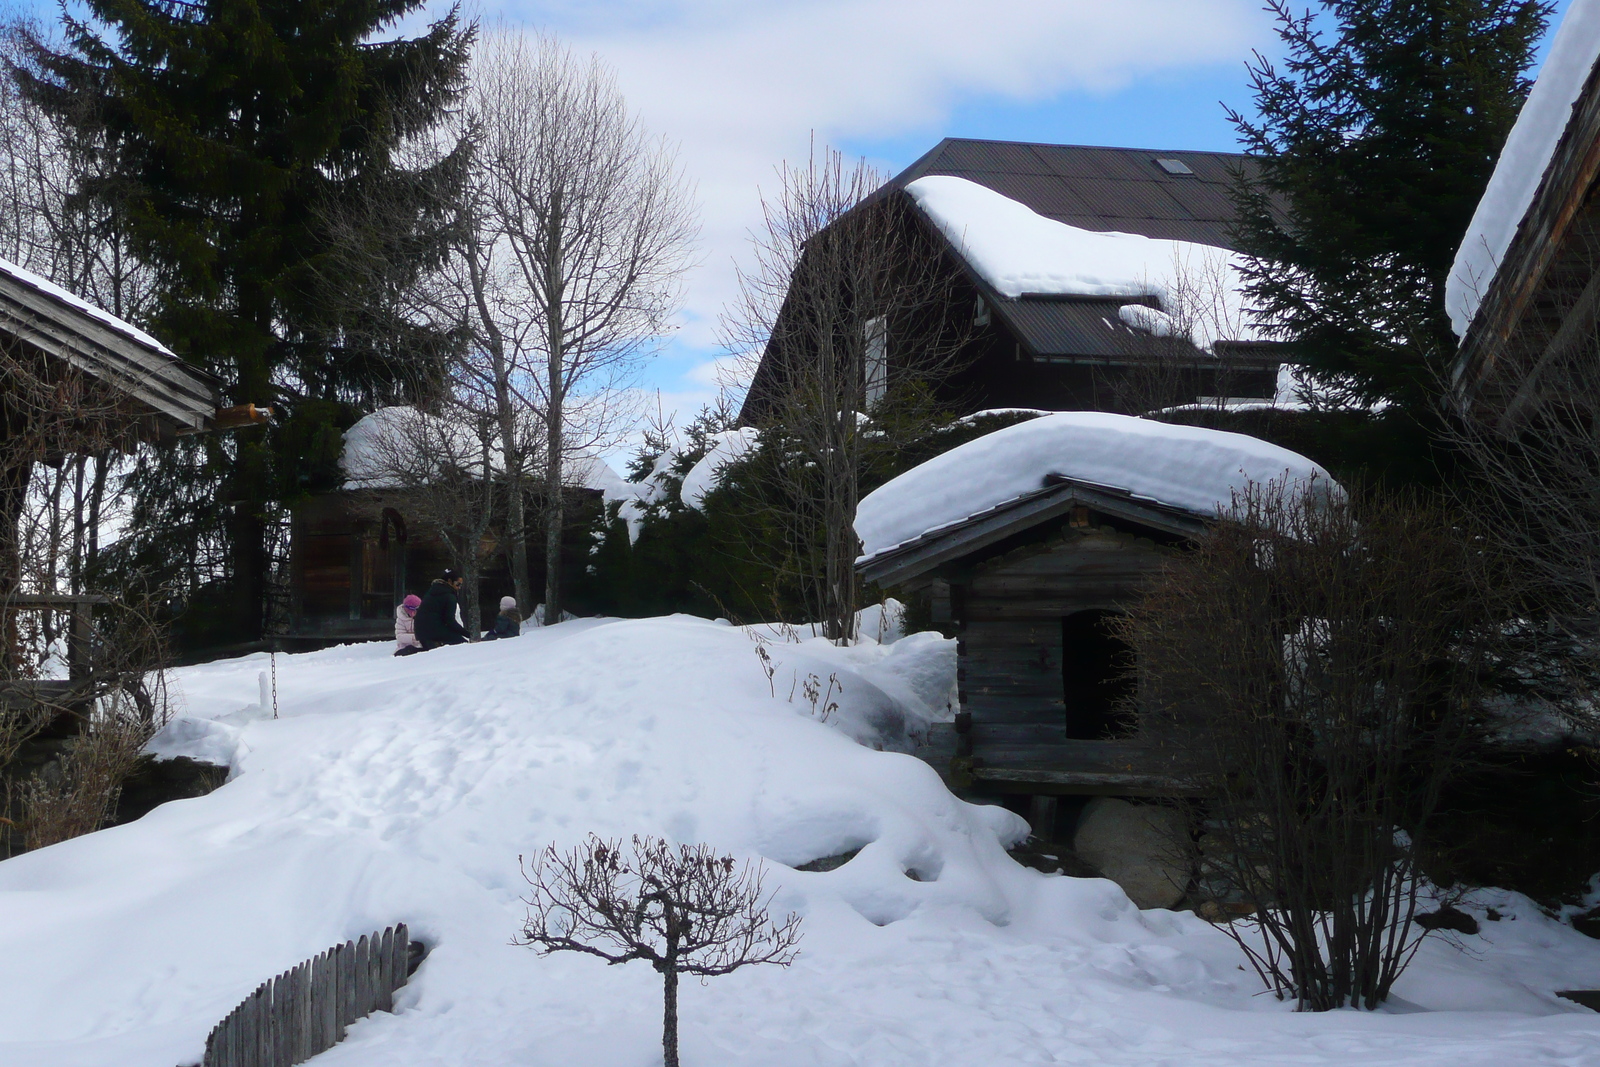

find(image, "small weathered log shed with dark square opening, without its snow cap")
[861,478,1205,797]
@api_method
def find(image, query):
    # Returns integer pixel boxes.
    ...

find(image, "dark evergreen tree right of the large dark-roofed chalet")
[1229,0,1550,414]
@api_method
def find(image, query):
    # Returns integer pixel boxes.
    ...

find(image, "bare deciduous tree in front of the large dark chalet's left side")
[723,150,973,643]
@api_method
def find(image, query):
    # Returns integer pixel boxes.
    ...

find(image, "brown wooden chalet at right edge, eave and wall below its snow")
[1453,34,1600,415]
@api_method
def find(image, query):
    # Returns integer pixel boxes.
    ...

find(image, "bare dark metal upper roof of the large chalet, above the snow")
[890,138,1256,248]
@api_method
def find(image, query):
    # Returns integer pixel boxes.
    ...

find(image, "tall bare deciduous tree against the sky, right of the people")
[464,30,698,622]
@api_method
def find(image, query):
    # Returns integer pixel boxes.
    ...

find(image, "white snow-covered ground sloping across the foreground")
[0,617,1600,1067]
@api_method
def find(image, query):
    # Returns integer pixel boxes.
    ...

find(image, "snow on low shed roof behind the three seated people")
[339,405,627,499]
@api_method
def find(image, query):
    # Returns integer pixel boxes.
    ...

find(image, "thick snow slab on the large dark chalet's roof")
[906,176,1256,350]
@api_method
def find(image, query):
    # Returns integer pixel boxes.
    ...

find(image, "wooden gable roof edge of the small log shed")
[856,475,1206,584]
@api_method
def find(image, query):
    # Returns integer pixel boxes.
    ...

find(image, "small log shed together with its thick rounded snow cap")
[856,413,1334,809]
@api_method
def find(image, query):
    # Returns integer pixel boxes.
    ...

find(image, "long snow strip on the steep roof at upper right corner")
[1445,0,1600,336]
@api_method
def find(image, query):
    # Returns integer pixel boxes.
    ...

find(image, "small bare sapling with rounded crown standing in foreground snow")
[517,833,800,1067]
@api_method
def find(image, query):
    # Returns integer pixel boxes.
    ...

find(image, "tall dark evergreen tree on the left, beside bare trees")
[13,0,472,638]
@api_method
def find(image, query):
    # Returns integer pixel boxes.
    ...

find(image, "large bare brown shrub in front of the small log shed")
[1120,485,1504,1011]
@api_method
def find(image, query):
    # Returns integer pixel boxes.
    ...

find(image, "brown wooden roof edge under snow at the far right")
[1451,59,1600,411]
